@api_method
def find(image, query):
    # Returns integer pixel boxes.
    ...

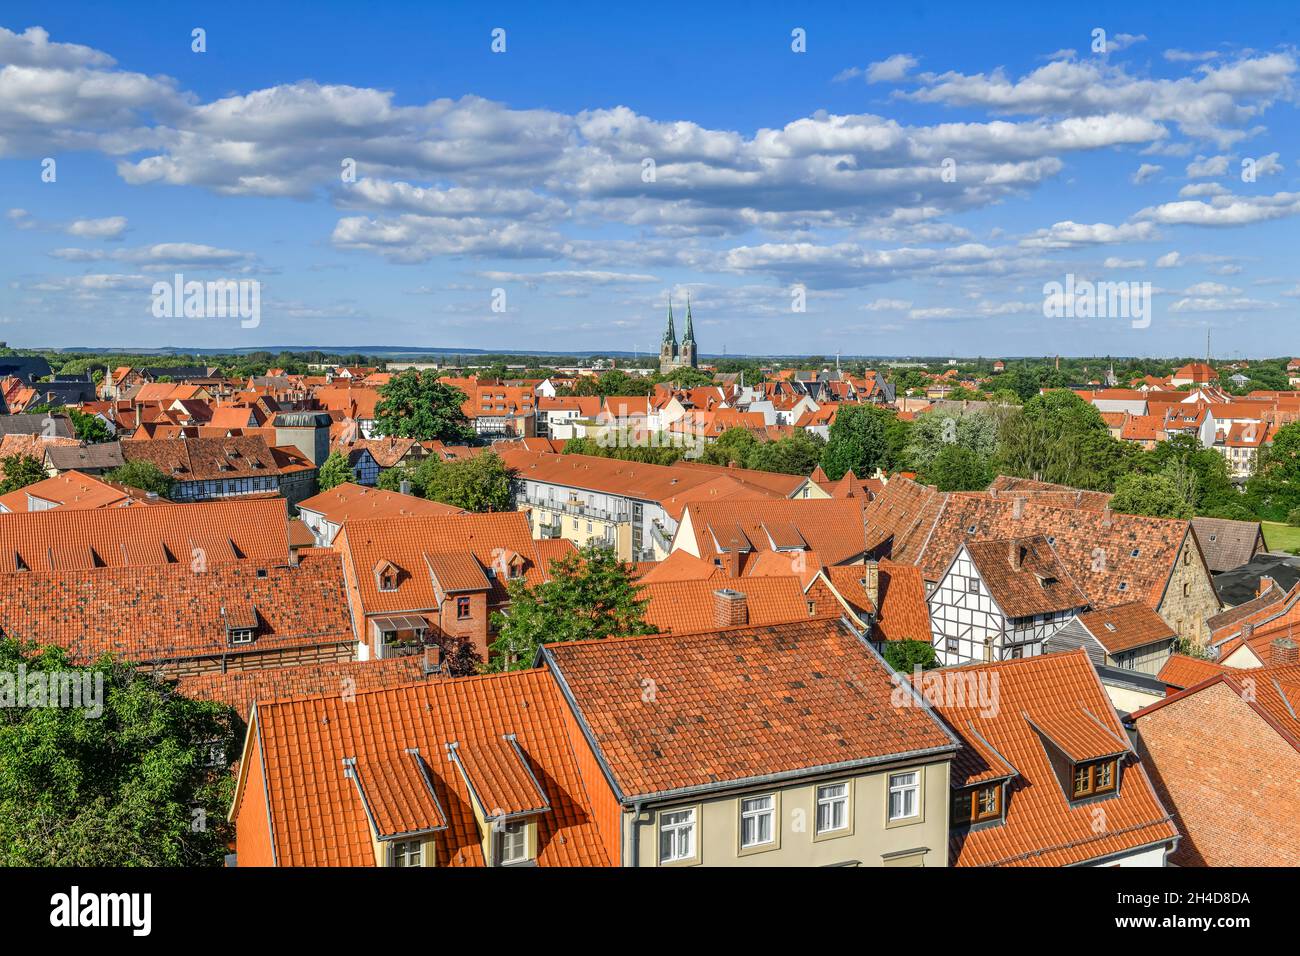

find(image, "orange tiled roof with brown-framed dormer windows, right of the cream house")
[919,650,1178,866]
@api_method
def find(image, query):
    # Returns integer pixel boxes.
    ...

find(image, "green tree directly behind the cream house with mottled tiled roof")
[488,544,655,671]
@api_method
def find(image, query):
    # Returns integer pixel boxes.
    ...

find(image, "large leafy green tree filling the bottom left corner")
[0,637,243,866]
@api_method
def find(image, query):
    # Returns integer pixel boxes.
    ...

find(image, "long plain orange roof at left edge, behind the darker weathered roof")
[0,498,289,571]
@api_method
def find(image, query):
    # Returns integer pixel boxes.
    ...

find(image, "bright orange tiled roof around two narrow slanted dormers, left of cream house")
[244,670,616,866]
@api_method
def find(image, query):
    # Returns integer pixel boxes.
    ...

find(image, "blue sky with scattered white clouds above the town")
[0,3,1300,356]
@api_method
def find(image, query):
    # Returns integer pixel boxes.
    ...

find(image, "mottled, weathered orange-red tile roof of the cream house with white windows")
[542,617,954,803]
